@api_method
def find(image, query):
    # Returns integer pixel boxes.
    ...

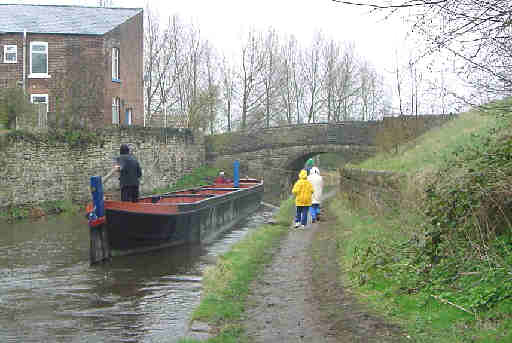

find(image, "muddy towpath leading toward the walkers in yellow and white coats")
[244,207,410,343]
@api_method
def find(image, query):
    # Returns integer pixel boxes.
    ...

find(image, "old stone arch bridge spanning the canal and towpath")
[205,115,453,202]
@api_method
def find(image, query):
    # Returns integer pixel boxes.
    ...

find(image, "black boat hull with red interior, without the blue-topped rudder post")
[104,182,263,256]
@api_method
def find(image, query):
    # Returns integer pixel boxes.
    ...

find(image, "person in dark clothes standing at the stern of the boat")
[116,144,142,202]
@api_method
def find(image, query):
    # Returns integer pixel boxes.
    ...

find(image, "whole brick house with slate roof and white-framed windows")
[0,4,144,127]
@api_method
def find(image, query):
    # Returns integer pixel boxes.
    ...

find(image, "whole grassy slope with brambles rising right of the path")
[331,101,512,343]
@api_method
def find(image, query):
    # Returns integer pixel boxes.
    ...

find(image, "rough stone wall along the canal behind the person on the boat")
[0,127,205,207]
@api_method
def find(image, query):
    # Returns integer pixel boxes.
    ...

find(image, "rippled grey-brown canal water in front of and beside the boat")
[0,206,273,343]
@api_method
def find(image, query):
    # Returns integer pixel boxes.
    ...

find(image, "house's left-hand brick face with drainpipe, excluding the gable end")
[0,33,106,126]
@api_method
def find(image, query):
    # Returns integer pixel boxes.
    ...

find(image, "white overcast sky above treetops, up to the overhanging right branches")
[0,0,414,74]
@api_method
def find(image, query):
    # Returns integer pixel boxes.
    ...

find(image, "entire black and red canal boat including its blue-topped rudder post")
[87,178,263,264]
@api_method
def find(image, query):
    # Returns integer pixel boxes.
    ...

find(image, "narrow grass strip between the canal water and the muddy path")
[180,200,294,343]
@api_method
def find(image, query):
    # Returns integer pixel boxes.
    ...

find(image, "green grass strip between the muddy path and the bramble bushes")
[330,194,512,343]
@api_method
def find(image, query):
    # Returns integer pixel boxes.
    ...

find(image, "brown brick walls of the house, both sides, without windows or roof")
[0,12,144,128]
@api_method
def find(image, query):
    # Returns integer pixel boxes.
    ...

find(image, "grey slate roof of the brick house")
[0,4,142,35]
